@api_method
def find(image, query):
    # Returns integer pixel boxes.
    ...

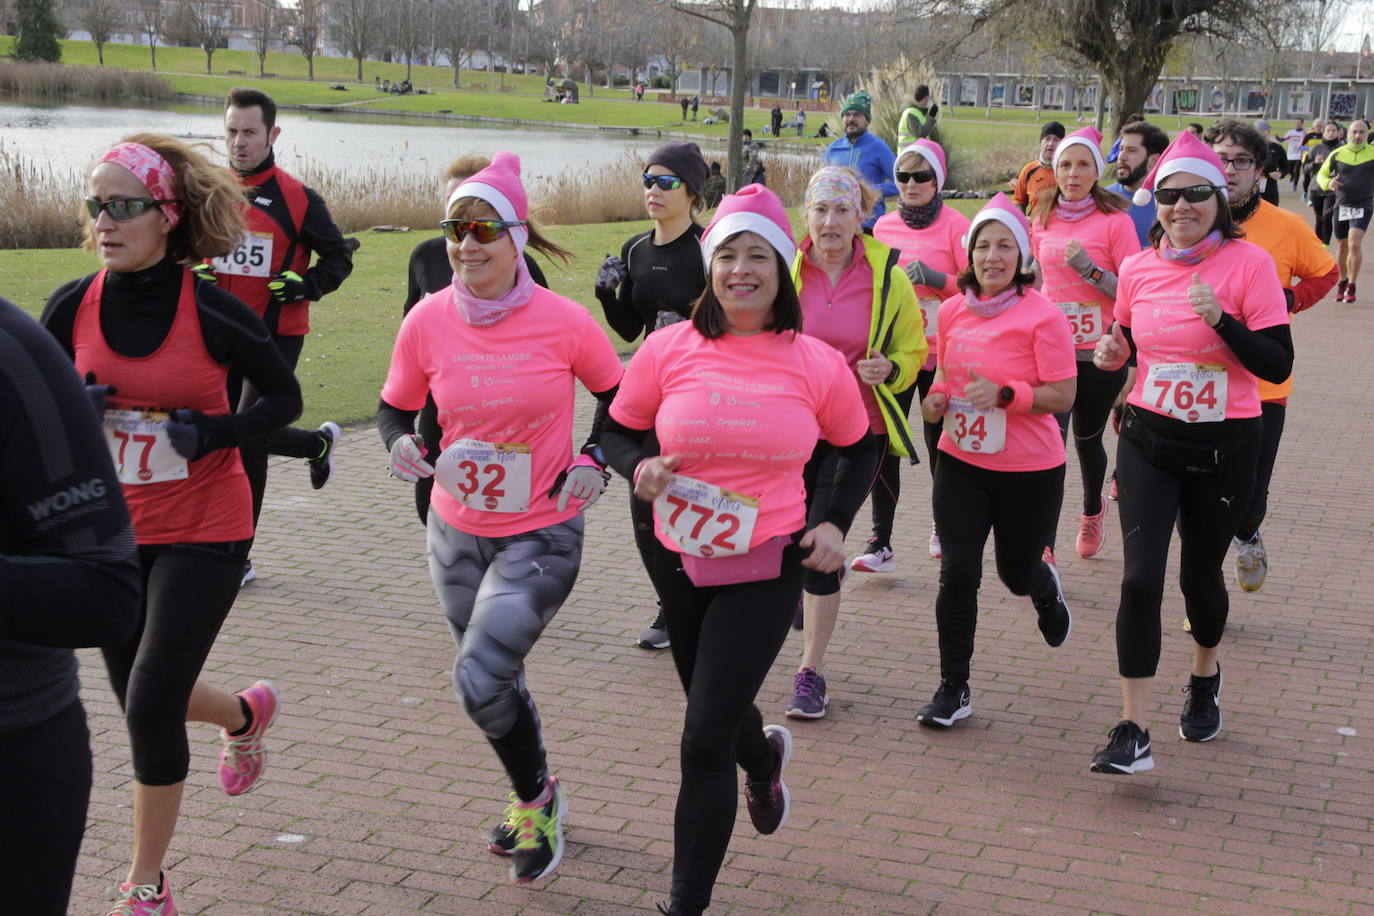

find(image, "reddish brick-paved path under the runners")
[72,241,1374,916]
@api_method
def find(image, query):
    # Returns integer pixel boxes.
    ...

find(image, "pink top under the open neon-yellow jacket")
[798,238,888,433]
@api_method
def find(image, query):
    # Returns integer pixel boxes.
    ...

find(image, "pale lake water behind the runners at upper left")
[0,103,676,179]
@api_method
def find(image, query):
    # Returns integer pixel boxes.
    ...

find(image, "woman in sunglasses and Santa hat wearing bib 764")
[1091,133,1293,775]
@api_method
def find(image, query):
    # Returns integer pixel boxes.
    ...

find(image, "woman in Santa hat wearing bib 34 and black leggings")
[916,194,1077,728]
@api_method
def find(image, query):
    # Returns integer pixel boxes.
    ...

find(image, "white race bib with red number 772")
[654,474,758,558]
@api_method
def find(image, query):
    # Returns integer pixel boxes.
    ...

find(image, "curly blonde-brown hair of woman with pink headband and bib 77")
[81,133,247,264]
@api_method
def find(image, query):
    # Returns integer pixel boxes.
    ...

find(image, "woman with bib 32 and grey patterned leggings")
[378,152,621,883]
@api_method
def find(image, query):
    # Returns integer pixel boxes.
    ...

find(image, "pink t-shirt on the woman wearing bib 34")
[940,288,1079,471]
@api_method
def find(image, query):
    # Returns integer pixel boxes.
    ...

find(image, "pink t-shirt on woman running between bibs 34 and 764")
[1031,207,1140,350]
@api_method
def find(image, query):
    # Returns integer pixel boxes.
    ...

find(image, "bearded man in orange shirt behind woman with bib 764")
[1202,118,1340,592]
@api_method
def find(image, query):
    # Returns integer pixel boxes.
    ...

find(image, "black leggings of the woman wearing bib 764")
[1117,419,1263,677]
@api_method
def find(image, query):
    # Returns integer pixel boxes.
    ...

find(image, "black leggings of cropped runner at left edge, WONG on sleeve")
[0,702,91,916]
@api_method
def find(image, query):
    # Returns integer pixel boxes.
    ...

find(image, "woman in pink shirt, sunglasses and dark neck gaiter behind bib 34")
[873,140,969,563]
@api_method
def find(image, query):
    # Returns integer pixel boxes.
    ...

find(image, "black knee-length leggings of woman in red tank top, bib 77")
[102,541,249,786]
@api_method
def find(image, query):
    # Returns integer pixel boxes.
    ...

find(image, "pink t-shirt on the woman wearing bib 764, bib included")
[1116,239,1289,423]
